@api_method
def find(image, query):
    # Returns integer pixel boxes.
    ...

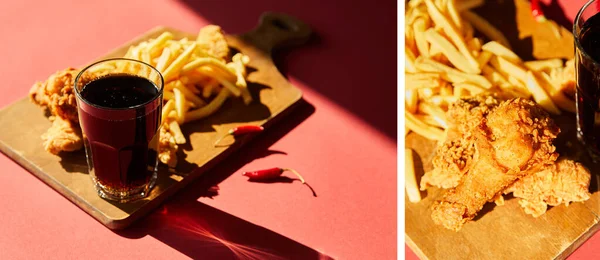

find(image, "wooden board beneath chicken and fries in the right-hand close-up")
[405,0,600,259]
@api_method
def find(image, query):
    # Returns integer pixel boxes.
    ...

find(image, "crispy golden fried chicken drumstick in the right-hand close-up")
[431,98,560,231]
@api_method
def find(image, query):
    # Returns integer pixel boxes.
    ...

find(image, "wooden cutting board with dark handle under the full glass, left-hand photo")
[0,13,311,229]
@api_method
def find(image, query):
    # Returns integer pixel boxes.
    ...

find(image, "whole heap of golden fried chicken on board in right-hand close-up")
[421,95,590,230]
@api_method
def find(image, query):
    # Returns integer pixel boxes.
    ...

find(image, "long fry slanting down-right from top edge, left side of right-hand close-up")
[425,0,479,73]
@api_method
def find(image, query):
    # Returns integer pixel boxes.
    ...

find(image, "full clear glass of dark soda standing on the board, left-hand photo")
[74,58,164,202]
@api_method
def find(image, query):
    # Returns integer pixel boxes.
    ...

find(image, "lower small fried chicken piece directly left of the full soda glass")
[42,117,83,154]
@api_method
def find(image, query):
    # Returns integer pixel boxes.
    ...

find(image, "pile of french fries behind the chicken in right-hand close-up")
[405,0,575,141]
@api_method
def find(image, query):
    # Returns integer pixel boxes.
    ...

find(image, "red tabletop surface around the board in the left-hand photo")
[0,0,397,259]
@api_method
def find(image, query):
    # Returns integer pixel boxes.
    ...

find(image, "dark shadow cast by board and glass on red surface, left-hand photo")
[116,101,331,259]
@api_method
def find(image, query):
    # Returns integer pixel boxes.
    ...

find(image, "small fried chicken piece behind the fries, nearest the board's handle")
[196,25,229,60]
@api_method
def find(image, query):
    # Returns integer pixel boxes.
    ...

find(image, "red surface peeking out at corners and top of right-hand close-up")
[405,0,600,260]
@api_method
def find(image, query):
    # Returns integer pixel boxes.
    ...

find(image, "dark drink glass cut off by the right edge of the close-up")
[573,0,600,161]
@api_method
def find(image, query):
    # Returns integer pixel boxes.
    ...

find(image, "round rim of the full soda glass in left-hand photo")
[73,58,165,110]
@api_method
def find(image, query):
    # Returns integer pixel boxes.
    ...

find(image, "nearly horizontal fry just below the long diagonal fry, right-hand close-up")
[415,57,492,89]
